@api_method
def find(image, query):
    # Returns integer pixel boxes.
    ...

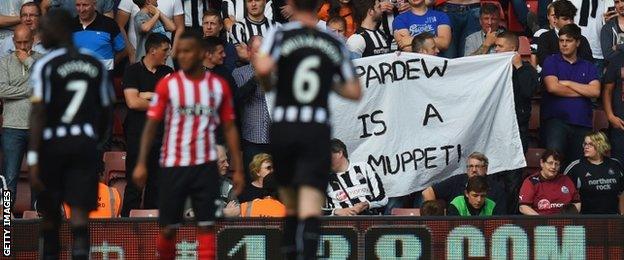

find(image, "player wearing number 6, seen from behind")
[254,0,361,259]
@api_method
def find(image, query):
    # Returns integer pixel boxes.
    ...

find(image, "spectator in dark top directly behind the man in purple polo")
[536,0,594,65]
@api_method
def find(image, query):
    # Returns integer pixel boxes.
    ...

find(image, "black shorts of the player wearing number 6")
[271,123,331,192]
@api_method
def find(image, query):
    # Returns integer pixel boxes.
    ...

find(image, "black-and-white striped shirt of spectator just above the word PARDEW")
[347,27,390,57]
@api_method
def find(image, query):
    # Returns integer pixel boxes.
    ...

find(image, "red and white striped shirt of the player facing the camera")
[147,71,235,167]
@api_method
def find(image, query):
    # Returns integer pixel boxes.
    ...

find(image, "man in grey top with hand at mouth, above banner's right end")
[464,3,503,56]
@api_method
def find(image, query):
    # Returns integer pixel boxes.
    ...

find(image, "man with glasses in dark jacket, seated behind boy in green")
[422,152,507,215]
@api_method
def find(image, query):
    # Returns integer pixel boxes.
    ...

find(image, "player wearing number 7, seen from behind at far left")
[27,10,113,260]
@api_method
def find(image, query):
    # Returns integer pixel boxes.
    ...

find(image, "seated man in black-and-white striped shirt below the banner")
[323,139,388,216]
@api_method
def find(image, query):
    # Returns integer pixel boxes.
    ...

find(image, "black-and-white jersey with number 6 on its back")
[260,22,354,124]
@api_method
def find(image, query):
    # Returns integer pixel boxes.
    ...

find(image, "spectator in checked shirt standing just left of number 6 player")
[232,36,271,177]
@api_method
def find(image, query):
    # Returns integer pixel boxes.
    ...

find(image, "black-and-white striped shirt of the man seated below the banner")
[323,162,388,214]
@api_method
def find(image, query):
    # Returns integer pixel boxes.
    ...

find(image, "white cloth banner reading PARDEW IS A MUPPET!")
[330,53,526,197]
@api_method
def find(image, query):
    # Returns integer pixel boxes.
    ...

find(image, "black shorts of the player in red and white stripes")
[158,162,219,227]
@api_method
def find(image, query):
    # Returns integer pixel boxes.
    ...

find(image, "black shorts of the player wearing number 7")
[37,137,102,211]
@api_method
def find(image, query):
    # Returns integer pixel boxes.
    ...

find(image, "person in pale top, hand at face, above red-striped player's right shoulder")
[133,0,176,60]
